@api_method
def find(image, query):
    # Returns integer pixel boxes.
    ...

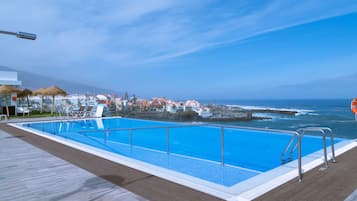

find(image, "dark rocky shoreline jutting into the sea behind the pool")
[124,105,298,122]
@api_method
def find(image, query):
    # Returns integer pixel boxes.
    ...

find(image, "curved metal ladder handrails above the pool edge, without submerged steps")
[297,127,336,182]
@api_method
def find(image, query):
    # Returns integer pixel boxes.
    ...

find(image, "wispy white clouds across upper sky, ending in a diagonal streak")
[0,0,357,71]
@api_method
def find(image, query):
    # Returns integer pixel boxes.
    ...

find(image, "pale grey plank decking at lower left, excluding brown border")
[0,125,146,201]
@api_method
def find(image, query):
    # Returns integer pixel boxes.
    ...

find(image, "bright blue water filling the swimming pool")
[24,118,342,186]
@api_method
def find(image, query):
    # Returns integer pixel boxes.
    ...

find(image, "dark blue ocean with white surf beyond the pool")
[200,99,357,139]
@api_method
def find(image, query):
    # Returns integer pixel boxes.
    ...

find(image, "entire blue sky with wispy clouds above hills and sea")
[0,0,357,99]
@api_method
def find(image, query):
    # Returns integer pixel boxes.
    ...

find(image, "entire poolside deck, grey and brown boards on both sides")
[0,118,357,201]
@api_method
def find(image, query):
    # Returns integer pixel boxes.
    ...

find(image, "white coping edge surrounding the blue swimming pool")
[8,119,357,200]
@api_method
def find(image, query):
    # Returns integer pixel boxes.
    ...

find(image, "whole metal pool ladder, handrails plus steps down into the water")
[281,127,336,181]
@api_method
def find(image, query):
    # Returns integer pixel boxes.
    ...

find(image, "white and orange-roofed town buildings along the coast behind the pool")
[0,80,212,118]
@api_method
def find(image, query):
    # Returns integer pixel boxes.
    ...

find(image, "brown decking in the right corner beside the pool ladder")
[255,145,357,201]
